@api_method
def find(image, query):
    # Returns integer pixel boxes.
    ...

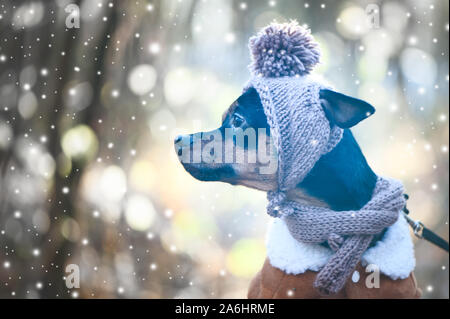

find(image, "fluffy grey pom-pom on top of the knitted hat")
[249,21,320,78]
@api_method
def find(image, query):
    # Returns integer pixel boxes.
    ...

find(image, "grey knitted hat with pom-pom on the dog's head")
[245,22,343,216]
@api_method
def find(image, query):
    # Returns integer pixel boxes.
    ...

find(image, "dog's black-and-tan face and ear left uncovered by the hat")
[175,88,375,191]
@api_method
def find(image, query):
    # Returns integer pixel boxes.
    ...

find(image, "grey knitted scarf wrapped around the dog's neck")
[268,177,405,295]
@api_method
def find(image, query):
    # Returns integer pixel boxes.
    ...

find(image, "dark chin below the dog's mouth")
[181,163,235,182]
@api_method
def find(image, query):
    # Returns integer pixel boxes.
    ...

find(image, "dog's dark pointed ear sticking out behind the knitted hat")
[320,89,375,128]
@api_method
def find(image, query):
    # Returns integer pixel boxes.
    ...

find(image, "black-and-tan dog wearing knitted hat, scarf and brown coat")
[175,21,421,298]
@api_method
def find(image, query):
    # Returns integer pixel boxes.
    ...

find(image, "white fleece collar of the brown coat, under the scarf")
[266,214,416,280]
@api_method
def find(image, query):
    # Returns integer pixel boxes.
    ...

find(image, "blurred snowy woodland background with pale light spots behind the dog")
[0,0,449,298]
